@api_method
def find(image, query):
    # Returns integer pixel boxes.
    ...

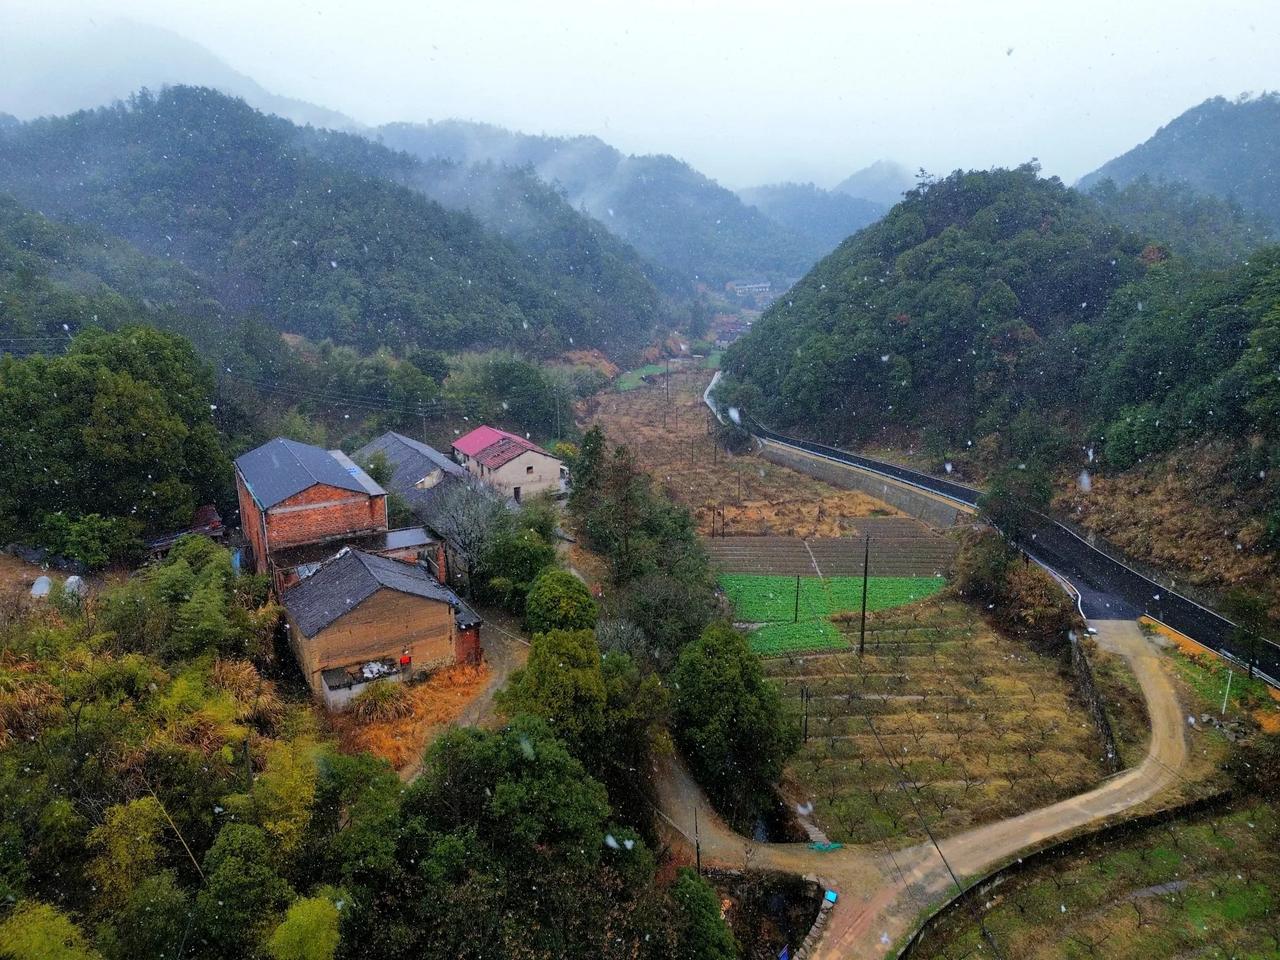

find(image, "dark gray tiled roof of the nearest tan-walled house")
[280,548,462,636]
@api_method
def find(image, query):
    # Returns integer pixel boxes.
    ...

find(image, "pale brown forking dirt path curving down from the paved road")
[655,620,1188,960]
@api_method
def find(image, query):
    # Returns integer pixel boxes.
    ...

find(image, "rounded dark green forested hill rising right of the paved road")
[726,166,1146,439]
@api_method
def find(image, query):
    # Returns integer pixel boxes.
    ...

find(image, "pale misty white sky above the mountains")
[0,0,1280,187]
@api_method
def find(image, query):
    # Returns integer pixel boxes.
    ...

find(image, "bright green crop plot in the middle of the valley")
[719,573,947,623]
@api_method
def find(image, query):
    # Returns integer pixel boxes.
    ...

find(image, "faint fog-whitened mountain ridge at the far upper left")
[0,18,360,129]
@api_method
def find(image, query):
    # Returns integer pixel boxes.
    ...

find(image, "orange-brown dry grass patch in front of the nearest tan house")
[330,664,489,771]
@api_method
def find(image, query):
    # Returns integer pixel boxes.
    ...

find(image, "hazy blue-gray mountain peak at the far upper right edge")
[1079,93,1280,228]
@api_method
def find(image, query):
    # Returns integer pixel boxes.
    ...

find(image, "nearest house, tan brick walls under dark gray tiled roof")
[280,548,480,710]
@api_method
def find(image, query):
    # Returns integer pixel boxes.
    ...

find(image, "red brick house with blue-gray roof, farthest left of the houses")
[236,436,387,573]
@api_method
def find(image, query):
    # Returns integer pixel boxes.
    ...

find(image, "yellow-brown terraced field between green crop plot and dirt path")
[762,599,1105,844]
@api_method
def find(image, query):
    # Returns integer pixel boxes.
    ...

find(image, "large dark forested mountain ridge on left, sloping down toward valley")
[0,87,663,352]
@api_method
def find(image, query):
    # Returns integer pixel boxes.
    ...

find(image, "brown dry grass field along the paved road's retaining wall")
[577,370,901,536]
